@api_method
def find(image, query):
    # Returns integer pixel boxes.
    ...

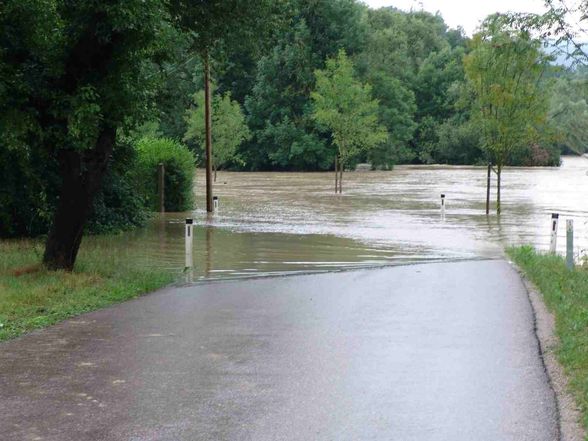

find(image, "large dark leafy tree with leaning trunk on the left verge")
[0,0,285,269]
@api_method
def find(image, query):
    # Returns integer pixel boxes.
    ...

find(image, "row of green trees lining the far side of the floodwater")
[171,1,586,204]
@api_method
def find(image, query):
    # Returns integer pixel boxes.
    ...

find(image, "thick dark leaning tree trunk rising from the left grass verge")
[43,129,116,271]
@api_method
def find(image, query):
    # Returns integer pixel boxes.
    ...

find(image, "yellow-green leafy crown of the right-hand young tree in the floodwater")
[464,19,549,169]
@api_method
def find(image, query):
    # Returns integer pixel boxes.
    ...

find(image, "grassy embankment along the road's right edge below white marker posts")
[508,247,588,429]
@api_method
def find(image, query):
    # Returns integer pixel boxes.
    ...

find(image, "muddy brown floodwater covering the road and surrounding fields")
[82,157,588,280]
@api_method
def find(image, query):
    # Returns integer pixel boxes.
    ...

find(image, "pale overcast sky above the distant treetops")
[363,0,545,35]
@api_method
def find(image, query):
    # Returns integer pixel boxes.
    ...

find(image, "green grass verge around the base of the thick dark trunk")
[0,238,174,341]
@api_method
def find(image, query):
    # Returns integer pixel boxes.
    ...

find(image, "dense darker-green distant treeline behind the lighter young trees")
[149,0,588,170]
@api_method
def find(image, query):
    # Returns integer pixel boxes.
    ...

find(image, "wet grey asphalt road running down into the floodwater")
[0,261,557,441]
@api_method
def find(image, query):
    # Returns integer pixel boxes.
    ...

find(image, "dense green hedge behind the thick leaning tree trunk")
[0,137,195,237]
